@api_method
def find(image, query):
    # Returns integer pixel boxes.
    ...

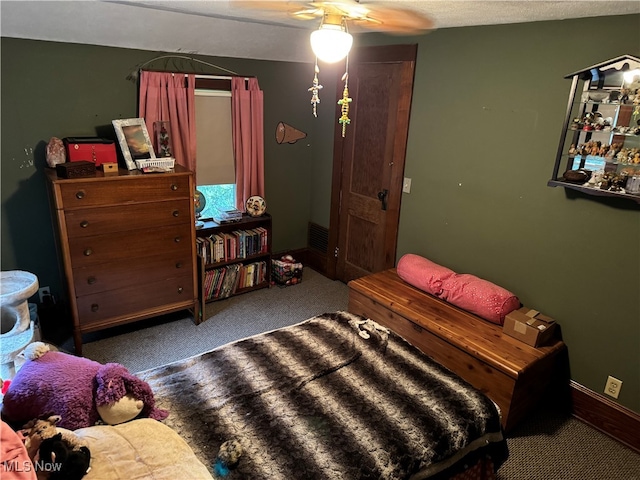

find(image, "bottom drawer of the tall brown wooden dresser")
[76,275,194,328]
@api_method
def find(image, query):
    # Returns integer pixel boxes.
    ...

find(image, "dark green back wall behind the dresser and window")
[1,38,318,296]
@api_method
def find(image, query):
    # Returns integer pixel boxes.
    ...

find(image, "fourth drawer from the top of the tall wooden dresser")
[73,252,193,297]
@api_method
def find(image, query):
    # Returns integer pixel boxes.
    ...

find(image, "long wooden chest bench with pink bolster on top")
[349,269,566,431]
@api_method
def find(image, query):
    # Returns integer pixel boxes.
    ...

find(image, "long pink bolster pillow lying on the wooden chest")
[397,254,520,325]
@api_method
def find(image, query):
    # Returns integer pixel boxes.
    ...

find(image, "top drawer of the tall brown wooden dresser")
[57,174,191,210]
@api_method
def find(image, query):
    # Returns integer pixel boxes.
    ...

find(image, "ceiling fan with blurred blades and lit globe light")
[232,0,434,63]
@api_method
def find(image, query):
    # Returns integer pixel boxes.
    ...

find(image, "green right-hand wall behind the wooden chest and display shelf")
[367,15,640,412]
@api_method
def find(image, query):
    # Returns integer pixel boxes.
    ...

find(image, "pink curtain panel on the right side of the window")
[231,77,264,211]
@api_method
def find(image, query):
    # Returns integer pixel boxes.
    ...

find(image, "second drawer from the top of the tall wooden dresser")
[64,199,191,238]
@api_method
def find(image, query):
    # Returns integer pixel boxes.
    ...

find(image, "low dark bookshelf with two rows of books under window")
[196,213,272,318]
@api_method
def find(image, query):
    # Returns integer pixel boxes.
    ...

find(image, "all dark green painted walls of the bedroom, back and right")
[1,15,640,412]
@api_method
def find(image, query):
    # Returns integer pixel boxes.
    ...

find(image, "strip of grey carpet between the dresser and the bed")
[62,269,348,372]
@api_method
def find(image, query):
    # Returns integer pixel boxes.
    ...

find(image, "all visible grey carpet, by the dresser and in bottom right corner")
[63,269,640,480]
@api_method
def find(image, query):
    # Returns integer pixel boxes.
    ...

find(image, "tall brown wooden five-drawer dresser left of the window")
[47,166,199,355]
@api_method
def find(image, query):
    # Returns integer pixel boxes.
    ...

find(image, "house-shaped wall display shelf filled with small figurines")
[547,55,640,204]
